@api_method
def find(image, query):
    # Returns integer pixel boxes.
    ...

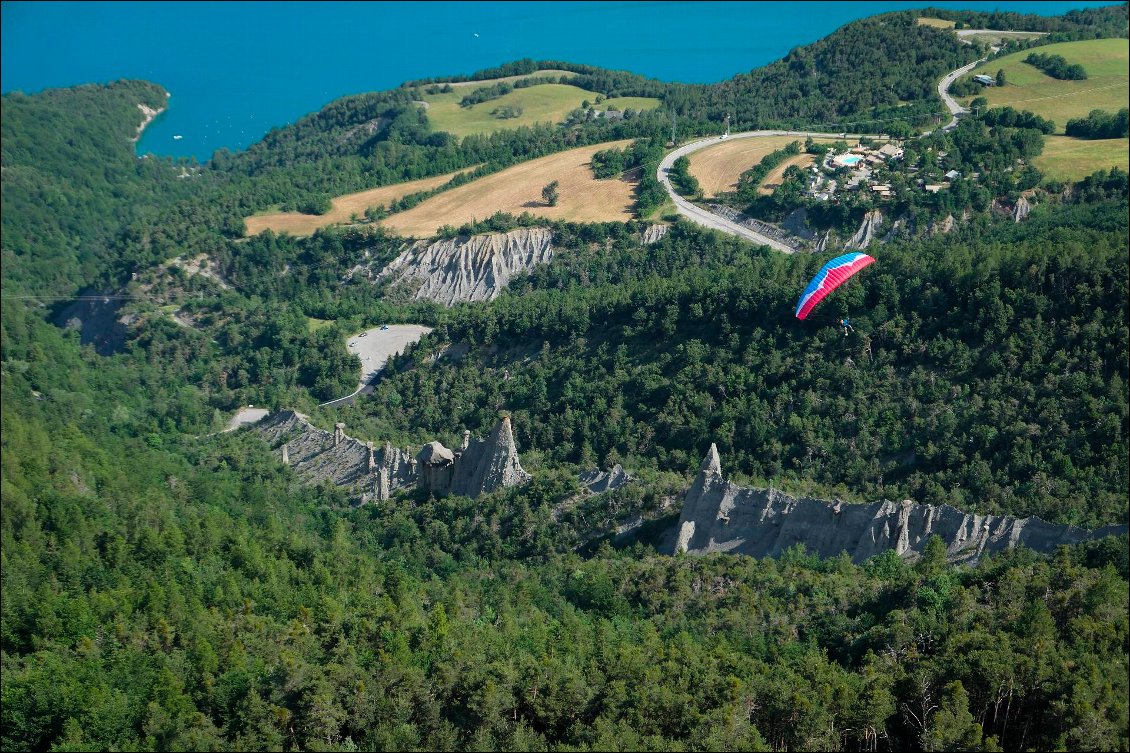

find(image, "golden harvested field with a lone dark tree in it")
[380,139,638,237]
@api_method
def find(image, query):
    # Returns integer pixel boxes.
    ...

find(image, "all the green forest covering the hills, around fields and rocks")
[0,6,1130,751]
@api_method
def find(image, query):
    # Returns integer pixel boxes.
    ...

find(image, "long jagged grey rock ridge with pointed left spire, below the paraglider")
[671,444,1127,563]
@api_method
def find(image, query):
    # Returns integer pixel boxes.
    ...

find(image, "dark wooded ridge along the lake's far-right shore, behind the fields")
[405,5,1128,133]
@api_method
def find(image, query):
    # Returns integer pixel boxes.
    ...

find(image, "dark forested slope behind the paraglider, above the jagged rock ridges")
[329,192,1130,526]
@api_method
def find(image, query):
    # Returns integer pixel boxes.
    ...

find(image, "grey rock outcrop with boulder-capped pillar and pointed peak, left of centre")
[255,410,530,503]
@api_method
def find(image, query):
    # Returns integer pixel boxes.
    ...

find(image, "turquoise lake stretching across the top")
[0,0,1111,161]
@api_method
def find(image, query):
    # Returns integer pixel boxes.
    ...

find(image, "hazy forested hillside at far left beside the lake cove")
[0,81,194,294]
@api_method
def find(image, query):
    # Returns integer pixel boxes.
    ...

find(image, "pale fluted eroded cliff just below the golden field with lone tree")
[377,227,554,306]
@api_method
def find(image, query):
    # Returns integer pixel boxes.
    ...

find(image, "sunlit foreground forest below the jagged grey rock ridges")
[0,308,1130,751]
